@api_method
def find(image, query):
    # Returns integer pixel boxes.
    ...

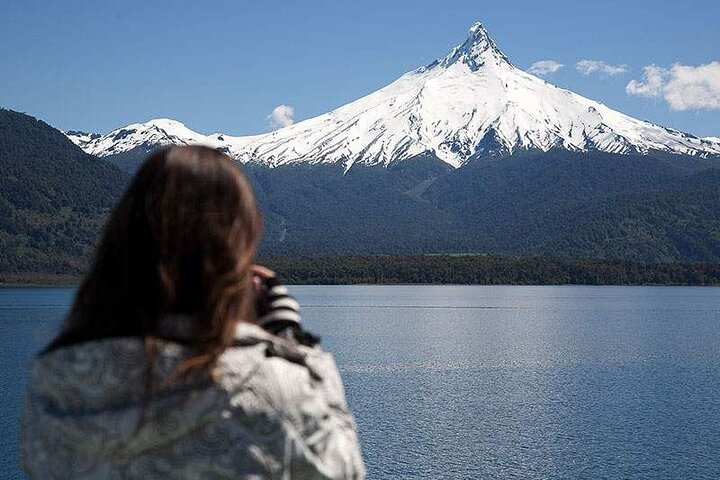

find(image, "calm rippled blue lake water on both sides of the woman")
[0,286,720,479]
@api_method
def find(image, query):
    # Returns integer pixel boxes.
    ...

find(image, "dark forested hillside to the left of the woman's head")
[0,109,127,275]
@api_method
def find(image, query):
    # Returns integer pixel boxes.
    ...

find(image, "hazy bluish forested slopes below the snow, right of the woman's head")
[248,150,720,262]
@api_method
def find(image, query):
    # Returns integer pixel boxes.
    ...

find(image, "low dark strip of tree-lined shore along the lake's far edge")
[0,254,720,286]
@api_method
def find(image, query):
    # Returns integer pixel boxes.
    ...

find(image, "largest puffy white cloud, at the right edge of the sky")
[625,62,720,110]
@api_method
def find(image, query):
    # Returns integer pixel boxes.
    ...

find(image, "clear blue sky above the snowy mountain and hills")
[0,0,720,136]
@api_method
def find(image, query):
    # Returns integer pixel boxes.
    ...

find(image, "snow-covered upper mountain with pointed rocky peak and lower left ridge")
[71,23,720,169]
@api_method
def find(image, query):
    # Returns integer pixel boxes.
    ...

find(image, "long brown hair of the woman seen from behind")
[46,146,262,376]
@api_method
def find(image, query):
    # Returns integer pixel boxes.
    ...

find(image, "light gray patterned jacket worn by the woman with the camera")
[21,323,365,480]
